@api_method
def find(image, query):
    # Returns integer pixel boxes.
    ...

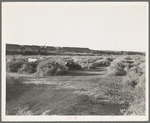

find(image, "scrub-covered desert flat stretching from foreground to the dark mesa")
[6,55,145,115]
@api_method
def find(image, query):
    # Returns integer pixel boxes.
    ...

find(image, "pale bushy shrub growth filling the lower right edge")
[123,63,146,116]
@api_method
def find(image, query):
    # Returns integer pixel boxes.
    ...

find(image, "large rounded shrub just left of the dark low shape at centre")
[35,60,68,76]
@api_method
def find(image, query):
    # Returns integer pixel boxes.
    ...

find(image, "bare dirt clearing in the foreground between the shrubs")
[6,67,128,115]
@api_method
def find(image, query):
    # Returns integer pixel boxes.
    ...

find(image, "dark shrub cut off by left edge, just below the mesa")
[6,61,23,72]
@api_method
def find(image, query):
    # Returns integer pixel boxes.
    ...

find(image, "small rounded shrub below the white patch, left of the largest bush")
[18,64,36,74]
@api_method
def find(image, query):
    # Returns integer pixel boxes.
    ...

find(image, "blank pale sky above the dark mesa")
[2,2,148,51]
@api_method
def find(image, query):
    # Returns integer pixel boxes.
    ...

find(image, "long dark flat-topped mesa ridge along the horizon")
[6,44,145,55]
